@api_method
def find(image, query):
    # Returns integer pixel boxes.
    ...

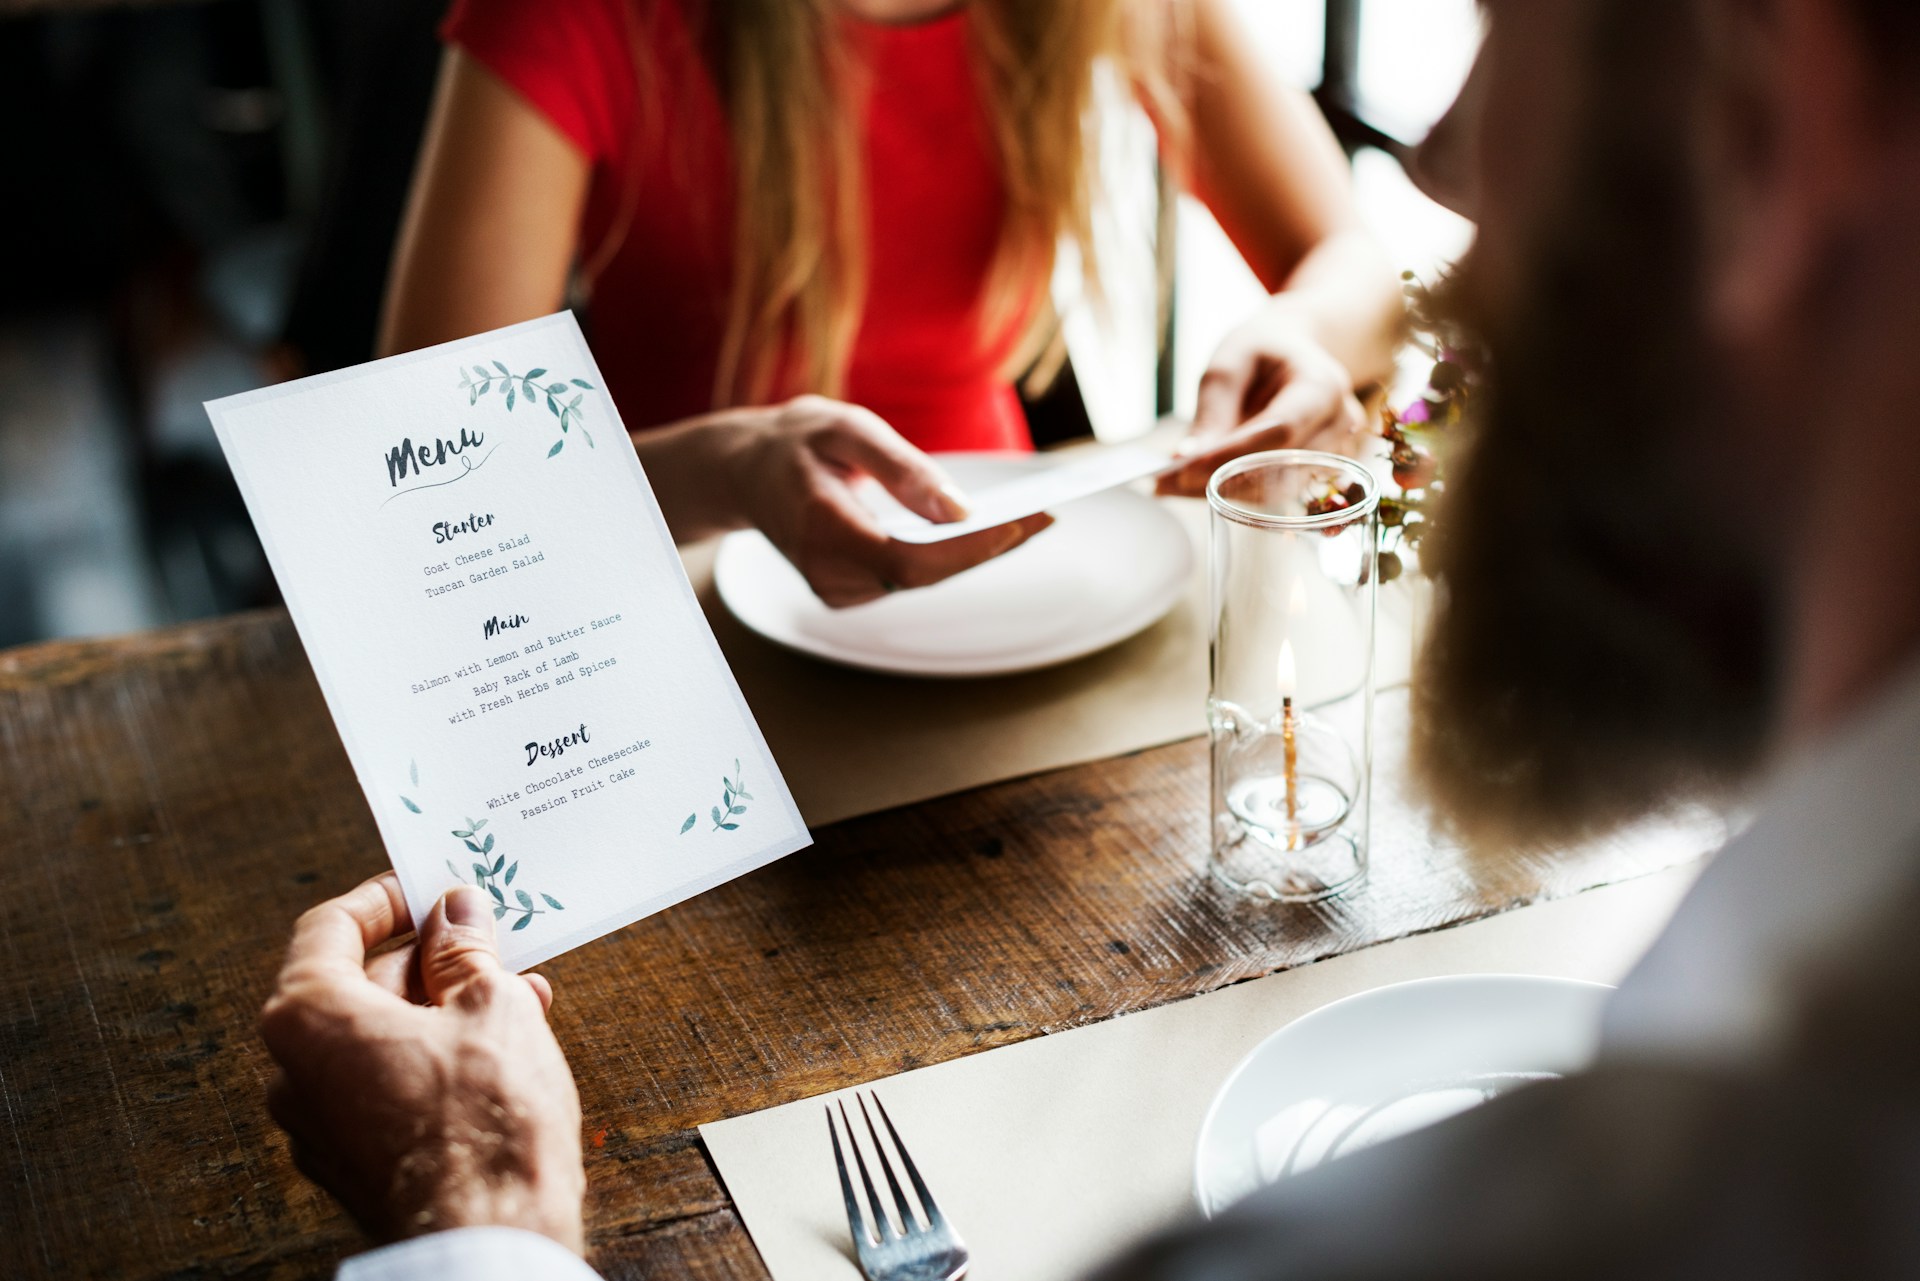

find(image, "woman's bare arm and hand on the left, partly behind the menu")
[380,50,1050,605]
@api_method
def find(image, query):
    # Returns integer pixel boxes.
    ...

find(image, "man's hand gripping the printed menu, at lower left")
[259,872,586,1252]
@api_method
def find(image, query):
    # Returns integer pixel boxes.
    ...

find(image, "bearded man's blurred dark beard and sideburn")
[1413,0,1774,847]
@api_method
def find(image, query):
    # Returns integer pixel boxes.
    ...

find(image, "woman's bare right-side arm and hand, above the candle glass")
[1164,0,1402,494]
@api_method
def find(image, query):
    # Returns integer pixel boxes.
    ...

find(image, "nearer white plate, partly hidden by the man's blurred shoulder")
[1194,974,1613,1218]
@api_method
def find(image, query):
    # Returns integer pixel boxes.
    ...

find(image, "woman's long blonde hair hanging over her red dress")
[595,0,1185,407]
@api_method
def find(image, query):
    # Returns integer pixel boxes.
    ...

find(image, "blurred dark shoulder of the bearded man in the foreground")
[1102,906,1920,1281]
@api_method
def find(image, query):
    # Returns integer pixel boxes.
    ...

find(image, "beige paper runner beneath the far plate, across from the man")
[682,499,1407,828]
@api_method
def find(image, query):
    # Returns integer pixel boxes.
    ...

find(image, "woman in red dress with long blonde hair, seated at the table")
[382,0,1400,605]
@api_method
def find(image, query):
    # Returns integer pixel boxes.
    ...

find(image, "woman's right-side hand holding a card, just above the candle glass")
[1160,311,1367,497]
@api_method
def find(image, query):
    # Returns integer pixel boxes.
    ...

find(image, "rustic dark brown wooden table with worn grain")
[0,613,1692,1281]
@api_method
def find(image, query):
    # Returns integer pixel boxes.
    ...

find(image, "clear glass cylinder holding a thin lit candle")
[1208,449,1380,903]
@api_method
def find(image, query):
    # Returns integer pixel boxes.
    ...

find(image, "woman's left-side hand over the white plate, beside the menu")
[705,396,1054,609]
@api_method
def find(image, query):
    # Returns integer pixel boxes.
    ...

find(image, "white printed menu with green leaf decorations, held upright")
[207,313,808,970]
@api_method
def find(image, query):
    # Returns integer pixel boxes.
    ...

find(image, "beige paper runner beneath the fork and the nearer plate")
[701,868,1695,1281]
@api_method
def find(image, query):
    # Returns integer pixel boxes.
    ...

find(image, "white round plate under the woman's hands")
[714,453,1194,676]
